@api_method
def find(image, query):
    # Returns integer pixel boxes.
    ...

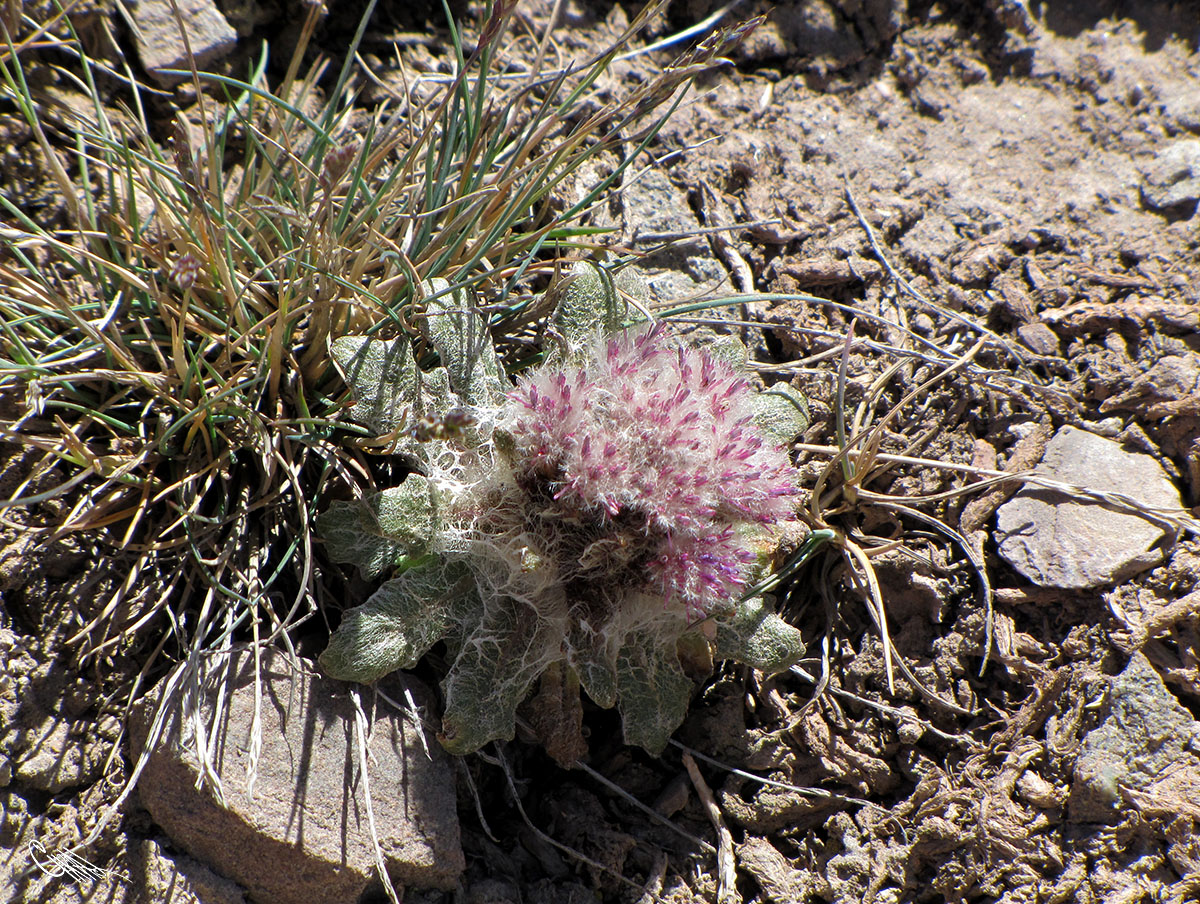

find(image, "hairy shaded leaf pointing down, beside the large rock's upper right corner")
[440,600,563,754]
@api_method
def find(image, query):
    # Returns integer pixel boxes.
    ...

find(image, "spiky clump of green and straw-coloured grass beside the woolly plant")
[0,2,739,681]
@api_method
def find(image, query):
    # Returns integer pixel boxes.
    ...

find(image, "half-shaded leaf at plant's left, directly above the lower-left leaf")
[317,474,439,579]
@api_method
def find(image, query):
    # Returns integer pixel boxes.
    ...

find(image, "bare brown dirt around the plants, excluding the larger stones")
[0,0,1200,904]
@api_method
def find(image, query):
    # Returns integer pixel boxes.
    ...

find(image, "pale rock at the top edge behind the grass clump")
[127,0,238,85]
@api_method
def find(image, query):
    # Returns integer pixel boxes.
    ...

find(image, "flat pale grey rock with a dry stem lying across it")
[996,427,1182,589]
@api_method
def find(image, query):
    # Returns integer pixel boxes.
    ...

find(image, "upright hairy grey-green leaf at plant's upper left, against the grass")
[421,279,504,405]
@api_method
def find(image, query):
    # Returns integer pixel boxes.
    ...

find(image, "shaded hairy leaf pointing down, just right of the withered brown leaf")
[617,634,692,755]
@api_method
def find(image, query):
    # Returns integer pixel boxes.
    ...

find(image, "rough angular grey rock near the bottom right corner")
[1068,651,1200,822]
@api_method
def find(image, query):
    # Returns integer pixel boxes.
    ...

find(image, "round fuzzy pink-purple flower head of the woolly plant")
[509,324,798,619]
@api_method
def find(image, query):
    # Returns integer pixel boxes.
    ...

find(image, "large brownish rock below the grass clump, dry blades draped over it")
[131,651,464,904]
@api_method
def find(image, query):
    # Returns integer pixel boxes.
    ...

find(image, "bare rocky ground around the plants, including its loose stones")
[0,0,1200,904]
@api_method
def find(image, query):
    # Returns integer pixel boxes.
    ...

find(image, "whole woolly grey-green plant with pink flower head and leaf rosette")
[318,264,804,764]
